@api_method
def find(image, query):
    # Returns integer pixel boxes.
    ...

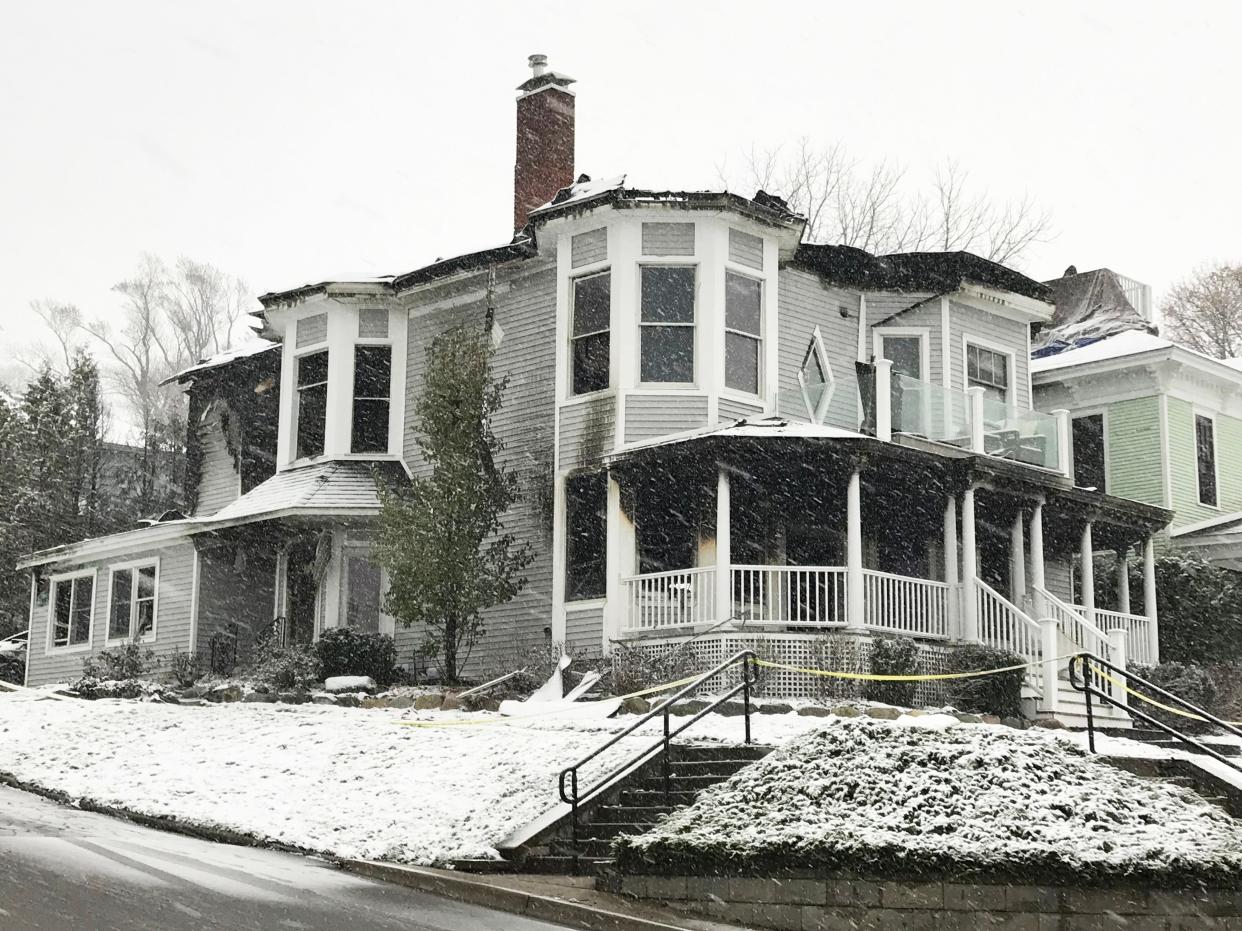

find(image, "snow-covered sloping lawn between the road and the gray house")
[0,693,821,864]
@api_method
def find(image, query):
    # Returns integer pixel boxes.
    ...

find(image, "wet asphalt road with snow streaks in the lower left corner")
[0,787,560,931]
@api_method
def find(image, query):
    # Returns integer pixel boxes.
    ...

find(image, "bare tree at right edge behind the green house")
[1163,263,1242,359]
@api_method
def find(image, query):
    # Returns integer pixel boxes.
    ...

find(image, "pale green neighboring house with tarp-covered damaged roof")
[1031,269,1242,569]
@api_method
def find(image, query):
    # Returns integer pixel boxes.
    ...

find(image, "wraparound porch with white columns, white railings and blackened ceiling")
[609,425,1165,724]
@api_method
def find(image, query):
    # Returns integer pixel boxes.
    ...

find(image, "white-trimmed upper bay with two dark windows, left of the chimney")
[265,282,407,469]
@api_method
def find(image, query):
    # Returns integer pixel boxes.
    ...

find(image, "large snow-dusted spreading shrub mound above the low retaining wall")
[616,719,1242,889]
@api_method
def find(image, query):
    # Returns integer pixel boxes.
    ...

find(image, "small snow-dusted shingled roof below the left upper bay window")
[196,462,400,528]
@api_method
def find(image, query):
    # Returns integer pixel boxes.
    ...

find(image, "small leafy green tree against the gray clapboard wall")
[376,325,533,681]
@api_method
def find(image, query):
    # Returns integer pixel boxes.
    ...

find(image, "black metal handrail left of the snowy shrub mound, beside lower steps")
[558,649,759,849]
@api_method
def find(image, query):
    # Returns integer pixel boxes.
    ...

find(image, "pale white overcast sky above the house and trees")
[0,0,1242,382]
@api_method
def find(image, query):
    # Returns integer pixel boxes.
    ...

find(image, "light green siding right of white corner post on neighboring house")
[1169,397,1242,528]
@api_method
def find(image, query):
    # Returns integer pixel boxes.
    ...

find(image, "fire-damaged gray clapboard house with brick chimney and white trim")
[14,57,1169,729]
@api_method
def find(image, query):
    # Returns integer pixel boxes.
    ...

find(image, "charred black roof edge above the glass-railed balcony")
[790,242,1053,303]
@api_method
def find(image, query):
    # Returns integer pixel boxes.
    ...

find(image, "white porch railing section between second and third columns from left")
[730,566,846,627]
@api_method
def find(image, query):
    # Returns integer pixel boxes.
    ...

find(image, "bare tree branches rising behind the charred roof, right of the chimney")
[718,138,1052,264]
